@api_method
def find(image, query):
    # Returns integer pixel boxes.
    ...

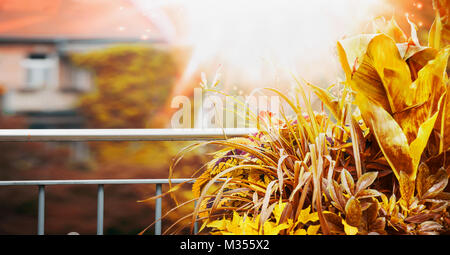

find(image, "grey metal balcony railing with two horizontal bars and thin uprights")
[0,128,257,235]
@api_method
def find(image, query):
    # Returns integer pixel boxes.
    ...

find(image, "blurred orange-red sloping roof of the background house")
[0,0,165,41]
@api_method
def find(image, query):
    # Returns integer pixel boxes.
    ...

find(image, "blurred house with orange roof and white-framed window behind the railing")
[0,0,172,128]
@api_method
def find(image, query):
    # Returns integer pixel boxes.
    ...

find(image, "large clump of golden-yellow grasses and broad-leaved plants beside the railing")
[147,1,450,235]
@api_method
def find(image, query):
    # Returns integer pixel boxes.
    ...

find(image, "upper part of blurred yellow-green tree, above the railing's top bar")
[72,45,179,128]
